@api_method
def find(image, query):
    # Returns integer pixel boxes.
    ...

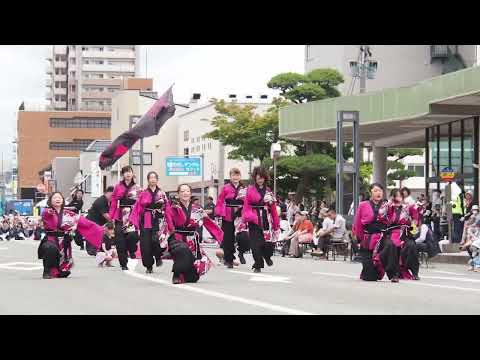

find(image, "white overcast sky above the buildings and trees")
[0,45,304,167]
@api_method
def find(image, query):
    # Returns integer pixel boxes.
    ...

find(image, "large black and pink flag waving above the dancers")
[99,87,175,170]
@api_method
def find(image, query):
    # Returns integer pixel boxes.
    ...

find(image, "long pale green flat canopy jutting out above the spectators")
[279,67,480,147]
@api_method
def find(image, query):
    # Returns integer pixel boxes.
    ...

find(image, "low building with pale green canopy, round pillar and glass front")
[279,66,480,210]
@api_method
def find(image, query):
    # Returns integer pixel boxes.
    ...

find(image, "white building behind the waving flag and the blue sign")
[106,90,271,198]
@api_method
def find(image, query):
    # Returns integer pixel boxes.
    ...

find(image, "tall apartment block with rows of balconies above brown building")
[46,45,139,111]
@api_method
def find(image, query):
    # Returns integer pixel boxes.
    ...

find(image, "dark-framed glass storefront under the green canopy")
[425,117,479,199]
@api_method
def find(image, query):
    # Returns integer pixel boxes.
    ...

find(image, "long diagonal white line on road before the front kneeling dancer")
[123,262,315,315]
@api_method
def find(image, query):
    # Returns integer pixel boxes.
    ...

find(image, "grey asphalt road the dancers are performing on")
[0,240,480,315]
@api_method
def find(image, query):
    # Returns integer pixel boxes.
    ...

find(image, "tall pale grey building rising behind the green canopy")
[305,45,479,95]
